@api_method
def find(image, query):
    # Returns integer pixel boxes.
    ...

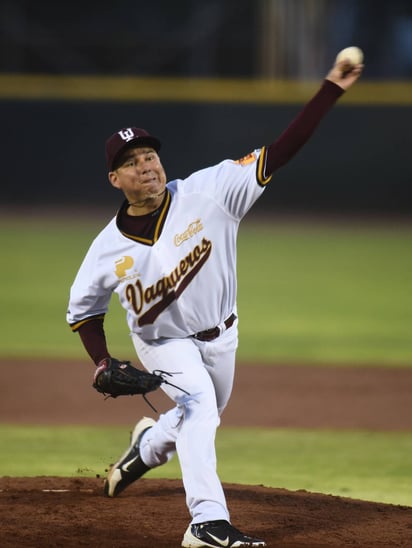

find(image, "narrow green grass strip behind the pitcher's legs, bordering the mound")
[0,425,412,506]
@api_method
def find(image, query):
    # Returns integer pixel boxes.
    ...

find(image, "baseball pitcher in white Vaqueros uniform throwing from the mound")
[67,56,363,548]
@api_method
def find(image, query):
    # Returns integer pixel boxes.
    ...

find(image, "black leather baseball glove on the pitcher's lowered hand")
[93,358,166,398]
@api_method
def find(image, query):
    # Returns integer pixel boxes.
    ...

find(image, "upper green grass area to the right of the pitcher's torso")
[235,223,412,366]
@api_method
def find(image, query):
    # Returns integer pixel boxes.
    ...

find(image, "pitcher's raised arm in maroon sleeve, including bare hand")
[263,48,363,177]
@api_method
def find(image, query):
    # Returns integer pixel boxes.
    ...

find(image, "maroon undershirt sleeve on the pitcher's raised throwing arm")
[264,80,344,177]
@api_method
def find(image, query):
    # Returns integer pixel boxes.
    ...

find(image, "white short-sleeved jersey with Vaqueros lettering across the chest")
[67,148,270,340]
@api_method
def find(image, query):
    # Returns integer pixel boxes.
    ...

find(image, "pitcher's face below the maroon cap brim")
[109,147,166,211]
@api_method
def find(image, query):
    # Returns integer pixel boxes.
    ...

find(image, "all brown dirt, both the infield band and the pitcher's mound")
[0,361,412,548]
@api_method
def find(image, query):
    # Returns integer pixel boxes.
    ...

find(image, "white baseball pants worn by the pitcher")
[132,320,238,523]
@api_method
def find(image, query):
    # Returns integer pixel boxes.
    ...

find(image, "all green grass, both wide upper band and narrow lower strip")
[0,216,412,505]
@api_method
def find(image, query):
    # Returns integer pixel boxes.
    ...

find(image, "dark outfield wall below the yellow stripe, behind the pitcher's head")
[0,100,412,214]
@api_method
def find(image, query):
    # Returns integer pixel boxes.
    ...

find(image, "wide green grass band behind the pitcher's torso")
[0,212,412,366]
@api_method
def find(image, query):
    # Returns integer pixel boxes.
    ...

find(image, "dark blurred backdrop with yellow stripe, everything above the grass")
[0,0,412,216]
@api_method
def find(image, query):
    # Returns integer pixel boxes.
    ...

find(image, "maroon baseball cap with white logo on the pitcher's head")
[106,127,161,171]
